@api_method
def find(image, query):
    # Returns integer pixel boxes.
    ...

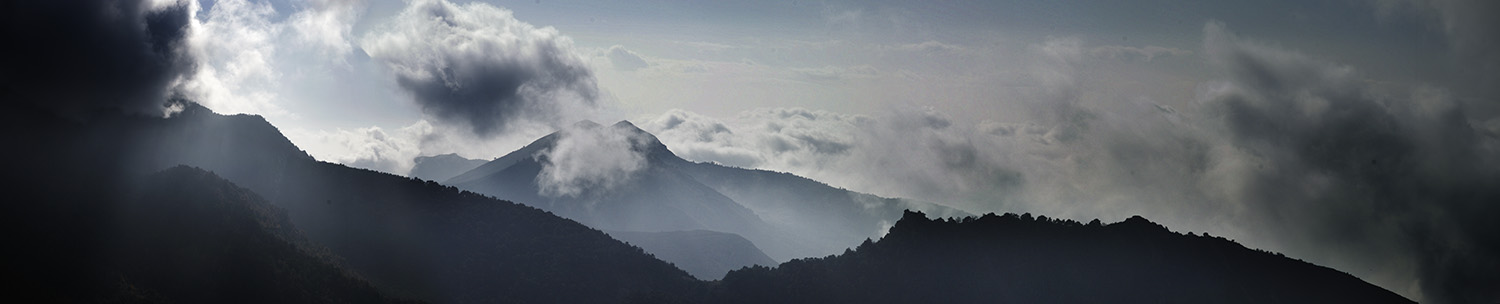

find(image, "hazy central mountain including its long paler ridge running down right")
[444,121,966,260]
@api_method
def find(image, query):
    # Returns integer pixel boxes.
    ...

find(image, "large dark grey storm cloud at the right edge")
[1205,24,1500,303]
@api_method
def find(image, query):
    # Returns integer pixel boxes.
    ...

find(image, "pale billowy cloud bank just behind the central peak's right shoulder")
[642,108,1020,208]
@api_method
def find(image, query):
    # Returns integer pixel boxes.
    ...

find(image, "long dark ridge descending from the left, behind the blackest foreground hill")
[0,105,701,303]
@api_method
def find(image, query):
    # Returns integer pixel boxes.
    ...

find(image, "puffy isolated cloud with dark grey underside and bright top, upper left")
[360,0,599,135]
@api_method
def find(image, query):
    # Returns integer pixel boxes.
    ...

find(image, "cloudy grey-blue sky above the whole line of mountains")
[0,0,1500,303]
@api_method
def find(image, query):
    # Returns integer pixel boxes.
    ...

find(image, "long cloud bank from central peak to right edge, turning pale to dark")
[642,22,1500,303]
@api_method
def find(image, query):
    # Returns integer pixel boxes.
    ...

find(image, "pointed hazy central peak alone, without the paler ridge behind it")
[449,121,771,235]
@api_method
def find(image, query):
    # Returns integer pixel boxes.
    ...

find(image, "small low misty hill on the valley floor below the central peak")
[608,231,776,280]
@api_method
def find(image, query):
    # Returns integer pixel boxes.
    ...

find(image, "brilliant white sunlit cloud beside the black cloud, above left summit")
[182,0,365,121]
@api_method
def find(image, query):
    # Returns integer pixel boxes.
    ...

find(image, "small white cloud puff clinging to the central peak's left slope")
[533,121,650,198]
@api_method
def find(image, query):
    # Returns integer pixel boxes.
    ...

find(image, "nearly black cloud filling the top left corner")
[0,0,195,114]
